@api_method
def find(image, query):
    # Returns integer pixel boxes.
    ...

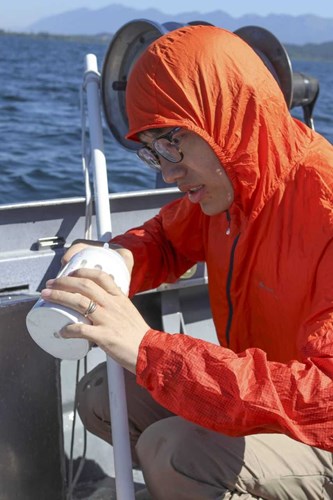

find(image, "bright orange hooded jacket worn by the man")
[114,26,333,451]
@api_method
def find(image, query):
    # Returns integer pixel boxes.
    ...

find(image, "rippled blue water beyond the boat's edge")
[0,35,333,204]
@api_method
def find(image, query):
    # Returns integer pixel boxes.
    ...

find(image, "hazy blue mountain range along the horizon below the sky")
[25,4,333,45]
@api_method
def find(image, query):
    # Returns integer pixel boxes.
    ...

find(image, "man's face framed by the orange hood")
[140,128,234,215]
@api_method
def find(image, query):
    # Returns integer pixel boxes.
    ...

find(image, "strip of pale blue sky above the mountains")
[0,0,333,30]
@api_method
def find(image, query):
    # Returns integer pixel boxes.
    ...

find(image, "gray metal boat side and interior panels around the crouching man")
[0,188,215,500]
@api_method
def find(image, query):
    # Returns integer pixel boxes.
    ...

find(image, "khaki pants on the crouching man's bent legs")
[78,363,333,500]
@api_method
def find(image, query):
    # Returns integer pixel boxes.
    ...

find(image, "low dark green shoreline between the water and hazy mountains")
[0,29,333,63]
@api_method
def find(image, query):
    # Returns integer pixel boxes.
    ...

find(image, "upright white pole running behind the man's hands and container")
[84,54,134,500]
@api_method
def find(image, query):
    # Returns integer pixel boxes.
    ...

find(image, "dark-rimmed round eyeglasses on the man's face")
[136,127,184,172]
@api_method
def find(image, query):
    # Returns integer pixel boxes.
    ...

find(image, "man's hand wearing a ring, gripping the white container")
[41,268,150,373]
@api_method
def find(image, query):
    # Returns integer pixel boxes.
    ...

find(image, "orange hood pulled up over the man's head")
[126,26,311,215]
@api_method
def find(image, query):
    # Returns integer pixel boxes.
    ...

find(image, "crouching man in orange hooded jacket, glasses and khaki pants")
[42,26,333,500]
